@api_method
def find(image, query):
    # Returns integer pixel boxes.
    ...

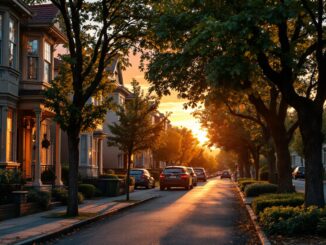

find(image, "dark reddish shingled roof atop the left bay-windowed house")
[28,4,59,25]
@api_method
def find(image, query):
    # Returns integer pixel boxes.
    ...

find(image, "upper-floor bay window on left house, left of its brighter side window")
[27,40,39,80]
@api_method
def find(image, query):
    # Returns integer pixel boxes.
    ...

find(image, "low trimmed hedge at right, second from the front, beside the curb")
[251,193,304,214]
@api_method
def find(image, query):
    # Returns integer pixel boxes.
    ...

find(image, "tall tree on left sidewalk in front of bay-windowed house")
[26,0,149,216]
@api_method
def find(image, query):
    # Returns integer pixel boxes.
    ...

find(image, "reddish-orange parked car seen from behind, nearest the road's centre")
[160,166,193,191]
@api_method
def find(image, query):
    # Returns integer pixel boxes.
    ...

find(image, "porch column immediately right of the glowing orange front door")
[33,108,42,186]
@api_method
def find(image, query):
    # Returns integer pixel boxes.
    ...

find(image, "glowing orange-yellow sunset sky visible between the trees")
[123,55,207,144]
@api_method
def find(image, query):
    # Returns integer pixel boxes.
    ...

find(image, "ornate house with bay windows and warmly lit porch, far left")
[0,0,66,186]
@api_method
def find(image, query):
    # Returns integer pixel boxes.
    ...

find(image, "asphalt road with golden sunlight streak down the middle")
[51,178,259,245]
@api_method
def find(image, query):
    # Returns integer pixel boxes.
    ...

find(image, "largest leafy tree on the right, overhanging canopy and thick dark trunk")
[147,0,326,207]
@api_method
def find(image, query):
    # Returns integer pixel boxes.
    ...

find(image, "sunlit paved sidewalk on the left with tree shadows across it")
[0,190,158,244]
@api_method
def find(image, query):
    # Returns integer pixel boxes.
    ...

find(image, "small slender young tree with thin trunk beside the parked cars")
[108,80,167,201]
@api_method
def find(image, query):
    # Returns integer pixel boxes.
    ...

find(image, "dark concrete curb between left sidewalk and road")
[14,195,160,245]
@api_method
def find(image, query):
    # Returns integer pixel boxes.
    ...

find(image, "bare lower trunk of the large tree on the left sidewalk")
[67,131,79,217]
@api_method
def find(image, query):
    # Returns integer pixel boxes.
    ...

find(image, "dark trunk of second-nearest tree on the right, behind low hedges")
[271,124,294,193]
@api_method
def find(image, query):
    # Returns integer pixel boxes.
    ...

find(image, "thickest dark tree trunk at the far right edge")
[298,105,325,208]
